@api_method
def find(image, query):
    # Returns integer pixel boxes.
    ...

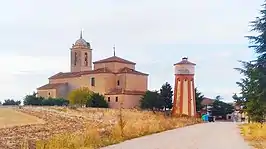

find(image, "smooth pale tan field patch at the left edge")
[0,107,44,128]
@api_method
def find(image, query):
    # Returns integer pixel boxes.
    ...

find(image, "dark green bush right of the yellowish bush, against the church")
[86,93,108,108]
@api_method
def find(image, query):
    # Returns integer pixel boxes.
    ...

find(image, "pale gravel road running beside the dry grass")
[102,122,251,149]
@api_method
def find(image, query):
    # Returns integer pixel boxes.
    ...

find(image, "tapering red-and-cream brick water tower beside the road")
[172,57,196,116]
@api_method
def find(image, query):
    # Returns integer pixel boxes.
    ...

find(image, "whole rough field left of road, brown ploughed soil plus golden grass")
[0,107,200,149]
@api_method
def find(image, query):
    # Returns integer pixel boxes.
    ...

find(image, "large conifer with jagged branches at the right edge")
[233,3,266,122]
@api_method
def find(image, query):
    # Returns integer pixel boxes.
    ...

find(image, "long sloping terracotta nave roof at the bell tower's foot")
[49,68,113,79]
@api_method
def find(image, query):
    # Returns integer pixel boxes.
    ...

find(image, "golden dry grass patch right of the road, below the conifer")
[240,123,266,149]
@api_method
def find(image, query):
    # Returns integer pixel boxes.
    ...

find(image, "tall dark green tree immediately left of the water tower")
[160,82,173,110]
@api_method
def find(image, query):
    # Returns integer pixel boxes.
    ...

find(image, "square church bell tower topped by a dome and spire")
[70,31,92,72]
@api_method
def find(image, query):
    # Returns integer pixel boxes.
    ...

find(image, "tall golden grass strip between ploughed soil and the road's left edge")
[33,109,200,149]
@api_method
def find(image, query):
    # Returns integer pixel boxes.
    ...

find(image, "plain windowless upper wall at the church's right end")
[123,74,148,91]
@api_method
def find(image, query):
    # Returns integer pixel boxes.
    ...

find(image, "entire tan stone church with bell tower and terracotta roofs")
[37,33,148,108]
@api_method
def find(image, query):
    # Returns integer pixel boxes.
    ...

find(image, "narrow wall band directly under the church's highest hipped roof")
[94,62,135,72]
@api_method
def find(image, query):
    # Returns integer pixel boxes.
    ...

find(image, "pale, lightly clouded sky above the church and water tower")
[0,0,263,101]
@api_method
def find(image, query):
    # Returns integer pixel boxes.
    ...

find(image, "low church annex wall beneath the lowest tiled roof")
[105,94,142,109]
